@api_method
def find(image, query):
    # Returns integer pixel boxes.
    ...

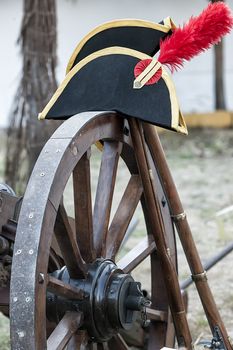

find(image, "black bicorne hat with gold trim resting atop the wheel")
[39,19,187,134]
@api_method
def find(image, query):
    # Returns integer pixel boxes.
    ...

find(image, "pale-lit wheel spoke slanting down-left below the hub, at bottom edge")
[47,312,82,350]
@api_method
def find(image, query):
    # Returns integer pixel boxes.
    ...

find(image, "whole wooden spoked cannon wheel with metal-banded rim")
[10,112,176,350]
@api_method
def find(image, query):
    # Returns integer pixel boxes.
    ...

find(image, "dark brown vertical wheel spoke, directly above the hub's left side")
[73,149,94,262]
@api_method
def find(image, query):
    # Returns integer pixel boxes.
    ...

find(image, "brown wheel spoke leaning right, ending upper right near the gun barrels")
[106,175,142,259]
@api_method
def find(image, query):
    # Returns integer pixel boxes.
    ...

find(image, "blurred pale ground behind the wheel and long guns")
[0,126,233,349]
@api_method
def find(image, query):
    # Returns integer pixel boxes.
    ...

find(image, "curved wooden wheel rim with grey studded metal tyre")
[10,112,176,349]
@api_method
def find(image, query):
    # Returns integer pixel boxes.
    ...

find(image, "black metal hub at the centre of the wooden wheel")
[47,259,149,341]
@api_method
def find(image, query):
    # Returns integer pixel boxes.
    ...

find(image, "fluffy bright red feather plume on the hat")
[158,2,233,72]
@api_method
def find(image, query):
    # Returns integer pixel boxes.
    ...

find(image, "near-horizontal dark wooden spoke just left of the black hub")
[47,275,83,300]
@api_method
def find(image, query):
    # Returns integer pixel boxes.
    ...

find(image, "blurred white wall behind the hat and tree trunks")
[0,0,233,126]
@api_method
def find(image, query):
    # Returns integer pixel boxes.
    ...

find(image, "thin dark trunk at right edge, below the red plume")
[211,0,226,109]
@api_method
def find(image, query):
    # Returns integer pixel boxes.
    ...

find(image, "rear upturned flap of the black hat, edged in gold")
[66,17,176,73]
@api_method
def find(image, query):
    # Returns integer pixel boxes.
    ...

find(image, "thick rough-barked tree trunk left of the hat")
[5,0,60,192]
